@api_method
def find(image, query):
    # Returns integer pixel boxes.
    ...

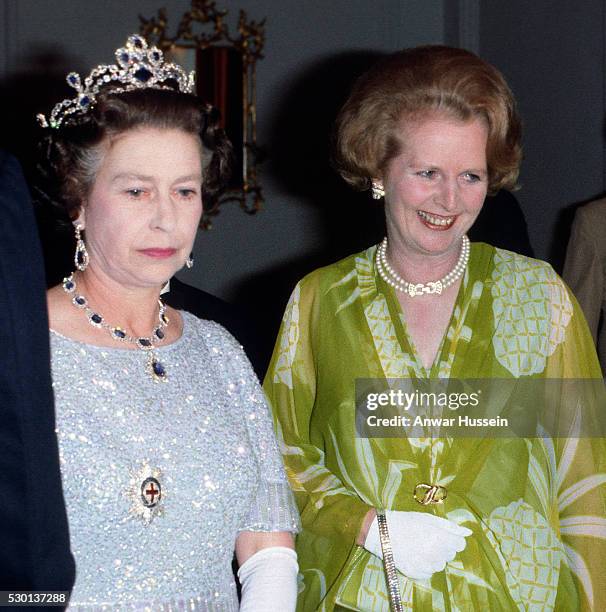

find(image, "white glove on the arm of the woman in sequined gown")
[238,546,299,612]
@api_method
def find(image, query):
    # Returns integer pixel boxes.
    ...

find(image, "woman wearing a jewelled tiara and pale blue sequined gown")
[39,35,298,612]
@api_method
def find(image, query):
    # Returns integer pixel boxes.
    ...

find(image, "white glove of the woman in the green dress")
[364,510,472,580]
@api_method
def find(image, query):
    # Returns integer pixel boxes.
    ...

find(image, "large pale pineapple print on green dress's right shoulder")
[492,249,572,377]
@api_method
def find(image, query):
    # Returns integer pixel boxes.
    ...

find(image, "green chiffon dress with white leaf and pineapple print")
[264,243,606,612]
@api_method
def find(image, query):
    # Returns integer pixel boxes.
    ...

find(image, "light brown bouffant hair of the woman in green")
[334,45,522,194]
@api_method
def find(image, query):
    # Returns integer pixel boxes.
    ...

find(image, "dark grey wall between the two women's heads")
[181,0,443,308]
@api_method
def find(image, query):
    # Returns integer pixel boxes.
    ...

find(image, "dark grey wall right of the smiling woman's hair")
[480,0,606,268]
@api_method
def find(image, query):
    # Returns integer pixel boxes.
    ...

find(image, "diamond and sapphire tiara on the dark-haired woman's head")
[37,34,195,128]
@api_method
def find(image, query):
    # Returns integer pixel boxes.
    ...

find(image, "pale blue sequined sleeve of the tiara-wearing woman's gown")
[202,323,300,532]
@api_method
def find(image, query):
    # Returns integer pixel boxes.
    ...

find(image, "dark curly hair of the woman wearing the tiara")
[33,88,233,220]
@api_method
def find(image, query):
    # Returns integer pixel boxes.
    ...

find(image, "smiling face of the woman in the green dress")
[383,115,488,255]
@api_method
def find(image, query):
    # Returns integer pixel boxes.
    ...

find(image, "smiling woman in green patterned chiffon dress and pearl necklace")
[265,46,606,612]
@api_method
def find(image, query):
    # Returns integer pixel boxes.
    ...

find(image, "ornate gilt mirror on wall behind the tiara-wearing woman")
[139,0,265,229]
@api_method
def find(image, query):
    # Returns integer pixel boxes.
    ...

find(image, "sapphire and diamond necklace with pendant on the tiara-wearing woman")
[62,273,169,382]
